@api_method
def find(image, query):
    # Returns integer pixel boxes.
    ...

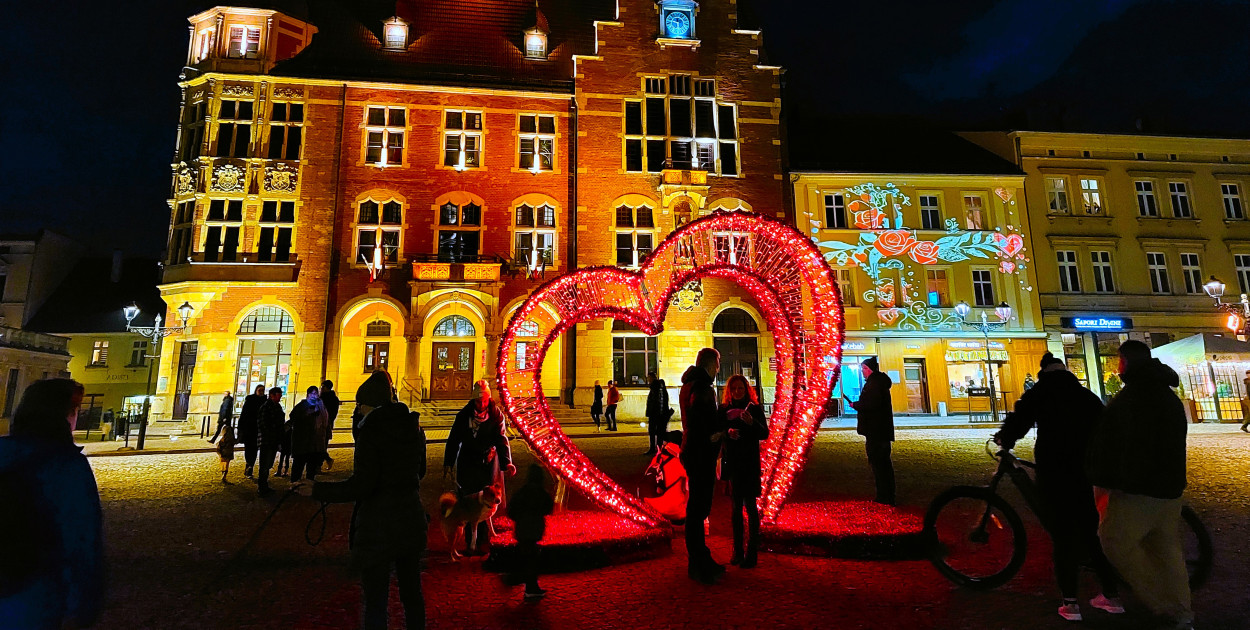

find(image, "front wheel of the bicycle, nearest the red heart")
[925,486,1029,589]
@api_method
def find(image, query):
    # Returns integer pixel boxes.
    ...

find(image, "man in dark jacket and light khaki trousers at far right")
[1086,340,1194,628]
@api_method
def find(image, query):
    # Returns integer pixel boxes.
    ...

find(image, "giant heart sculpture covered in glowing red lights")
[498,213,844,526]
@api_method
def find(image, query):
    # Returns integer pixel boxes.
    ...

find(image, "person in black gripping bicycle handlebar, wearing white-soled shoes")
[994,353,1124,621]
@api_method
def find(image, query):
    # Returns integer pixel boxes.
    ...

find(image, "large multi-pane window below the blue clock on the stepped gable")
[625,75,739,175]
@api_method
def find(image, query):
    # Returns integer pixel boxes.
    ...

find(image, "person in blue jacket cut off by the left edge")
[0,379,104,629]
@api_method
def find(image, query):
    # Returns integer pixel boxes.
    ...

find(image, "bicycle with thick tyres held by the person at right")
[924,439,1213,590]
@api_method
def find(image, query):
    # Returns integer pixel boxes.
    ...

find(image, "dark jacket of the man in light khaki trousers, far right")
[1085,359,1189,499]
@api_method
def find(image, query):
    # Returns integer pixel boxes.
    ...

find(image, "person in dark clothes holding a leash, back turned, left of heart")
[296,370,428,630]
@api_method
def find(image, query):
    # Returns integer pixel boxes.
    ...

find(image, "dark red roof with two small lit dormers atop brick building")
[273,0,616,91]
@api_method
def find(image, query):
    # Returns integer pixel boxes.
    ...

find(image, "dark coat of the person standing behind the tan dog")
[443,399,513,494]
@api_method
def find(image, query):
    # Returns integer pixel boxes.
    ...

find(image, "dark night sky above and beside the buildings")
[0,0,1250,255]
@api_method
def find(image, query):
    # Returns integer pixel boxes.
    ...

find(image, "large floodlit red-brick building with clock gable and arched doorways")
[155,0,784,420]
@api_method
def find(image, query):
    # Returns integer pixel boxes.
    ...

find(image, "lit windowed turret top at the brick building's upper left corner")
[186,6,316,74]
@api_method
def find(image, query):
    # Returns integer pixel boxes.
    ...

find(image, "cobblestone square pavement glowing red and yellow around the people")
[90,425,1250,630]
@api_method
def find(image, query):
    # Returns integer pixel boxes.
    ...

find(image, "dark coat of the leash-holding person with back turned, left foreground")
[313,403,428,568]
